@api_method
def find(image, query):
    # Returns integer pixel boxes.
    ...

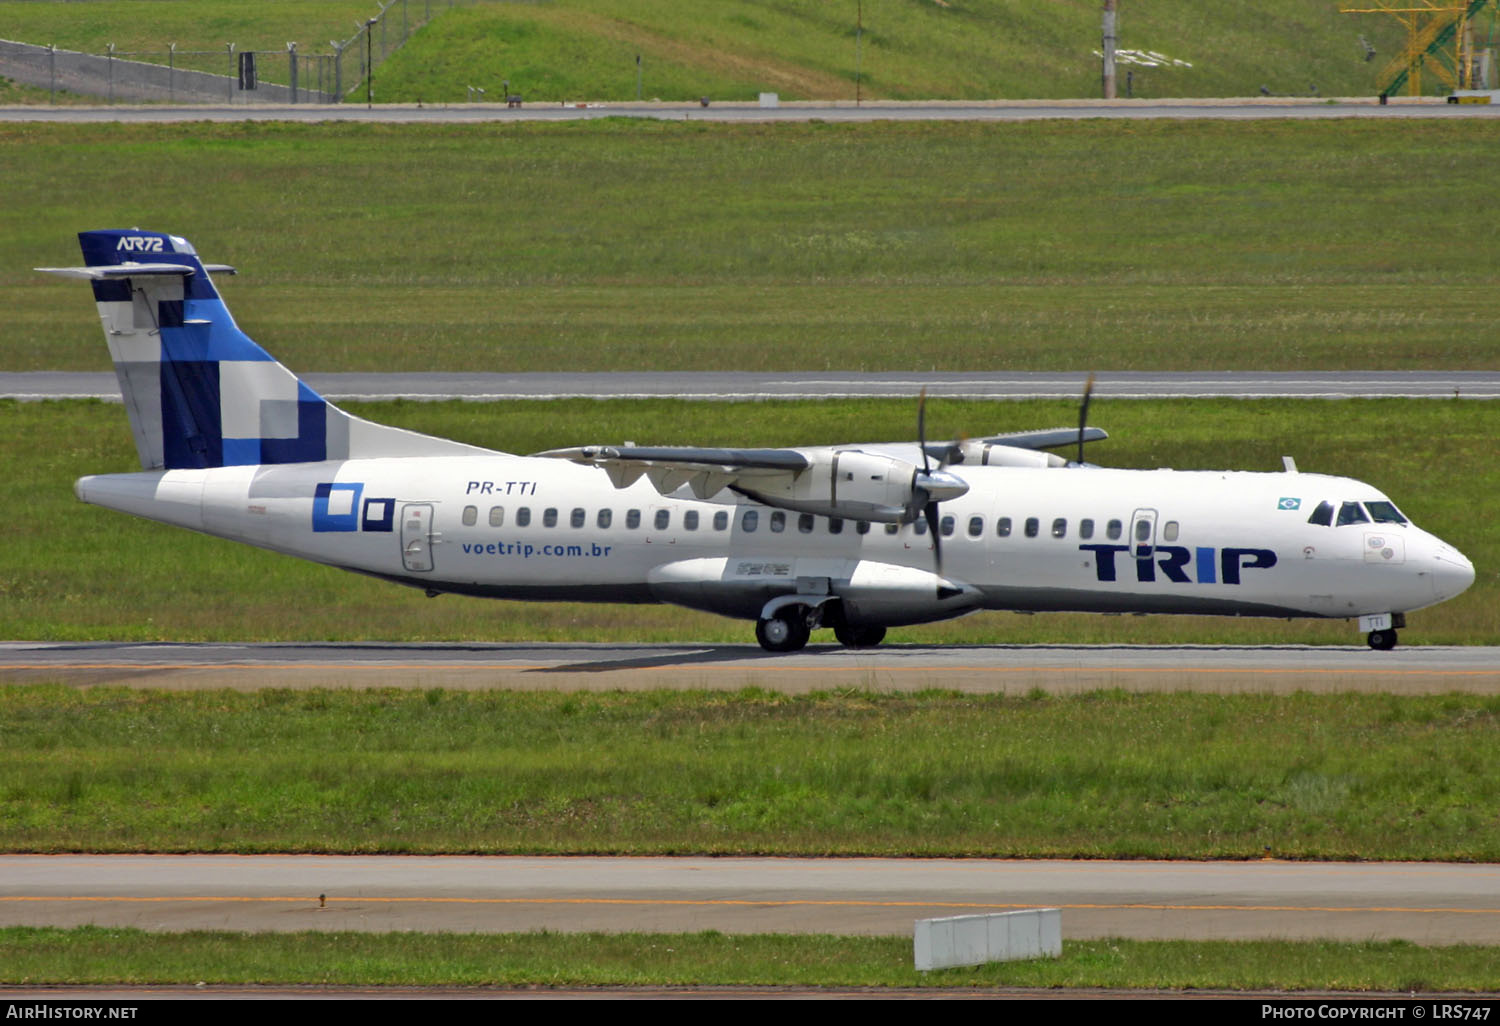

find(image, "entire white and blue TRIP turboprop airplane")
[39,228,1475,651]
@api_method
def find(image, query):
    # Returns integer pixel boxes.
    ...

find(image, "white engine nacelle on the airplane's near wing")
[734,449,936,524]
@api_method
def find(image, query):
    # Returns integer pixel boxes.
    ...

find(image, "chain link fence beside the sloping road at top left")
[0,0,459,104]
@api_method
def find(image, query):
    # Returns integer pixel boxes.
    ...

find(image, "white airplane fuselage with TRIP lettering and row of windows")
[78,455,1473,626]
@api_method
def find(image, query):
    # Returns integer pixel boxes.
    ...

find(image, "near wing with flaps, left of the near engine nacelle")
[536,446,812,498]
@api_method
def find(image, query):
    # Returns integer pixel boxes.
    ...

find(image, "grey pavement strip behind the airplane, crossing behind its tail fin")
[11,371,1500,402]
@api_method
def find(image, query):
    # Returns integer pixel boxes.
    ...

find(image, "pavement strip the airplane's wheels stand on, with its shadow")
[0,642,1500,695]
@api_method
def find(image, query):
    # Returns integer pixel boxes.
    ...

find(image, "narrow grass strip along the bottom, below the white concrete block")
[0,927,1500,993]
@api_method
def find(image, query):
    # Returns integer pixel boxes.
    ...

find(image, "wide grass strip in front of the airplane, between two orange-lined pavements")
[0,690,1500,861]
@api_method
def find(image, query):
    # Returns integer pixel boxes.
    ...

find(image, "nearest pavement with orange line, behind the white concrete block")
[0,855,1500,944]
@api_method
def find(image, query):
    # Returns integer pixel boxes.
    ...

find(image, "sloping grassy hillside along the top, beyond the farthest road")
[6,0,1401,104]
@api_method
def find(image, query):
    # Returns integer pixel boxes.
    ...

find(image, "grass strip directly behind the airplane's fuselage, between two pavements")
[0,396,1500,644]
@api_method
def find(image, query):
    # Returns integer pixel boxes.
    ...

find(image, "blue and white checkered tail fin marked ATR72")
[38,228,489,470]
